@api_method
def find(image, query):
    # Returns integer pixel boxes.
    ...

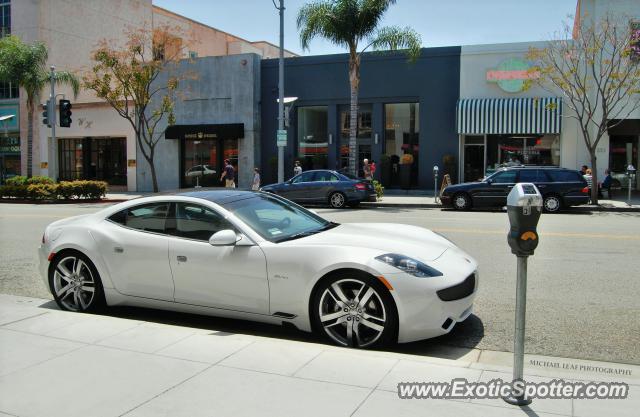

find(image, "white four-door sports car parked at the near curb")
[40,190,478,347]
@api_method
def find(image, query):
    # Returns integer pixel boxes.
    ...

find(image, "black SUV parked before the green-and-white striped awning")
[440,166,589,213]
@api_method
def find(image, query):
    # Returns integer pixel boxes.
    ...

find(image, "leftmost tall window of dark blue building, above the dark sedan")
[297,106,329,171]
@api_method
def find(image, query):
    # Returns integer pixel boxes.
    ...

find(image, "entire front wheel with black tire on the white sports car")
[309,270,398,348]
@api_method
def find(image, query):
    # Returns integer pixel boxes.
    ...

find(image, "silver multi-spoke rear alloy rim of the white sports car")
[53,256,96,311]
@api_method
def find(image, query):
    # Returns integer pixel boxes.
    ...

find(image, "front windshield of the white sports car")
[224,194,338,243]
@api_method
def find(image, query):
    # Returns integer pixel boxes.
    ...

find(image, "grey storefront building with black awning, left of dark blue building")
[136,54,260,191]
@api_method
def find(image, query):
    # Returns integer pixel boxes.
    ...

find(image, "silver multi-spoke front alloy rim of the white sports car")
[319,279,387,347]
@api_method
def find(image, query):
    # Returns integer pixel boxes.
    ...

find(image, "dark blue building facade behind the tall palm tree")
[260,47,460,189]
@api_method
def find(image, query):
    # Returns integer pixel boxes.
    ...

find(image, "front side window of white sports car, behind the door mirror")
[167,203,233,241]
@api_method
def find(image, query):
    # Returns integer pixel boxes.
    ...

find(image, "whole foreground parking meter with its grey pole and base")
[503,182,542,406]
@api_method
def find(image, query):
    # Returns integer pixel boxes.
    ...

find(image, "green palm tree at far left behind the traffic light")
[0,36,80,177]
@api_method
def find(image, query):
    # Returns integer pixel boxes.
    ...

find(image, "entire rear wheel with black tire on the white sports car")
[49,250,106,313]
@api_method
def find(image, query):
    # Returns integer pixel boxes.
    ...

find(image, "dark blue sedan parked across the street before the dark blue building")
[261,169,377,208]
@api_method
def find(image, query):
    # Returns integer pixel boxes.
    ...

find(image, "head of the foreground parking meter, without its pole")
[507,182,542,256]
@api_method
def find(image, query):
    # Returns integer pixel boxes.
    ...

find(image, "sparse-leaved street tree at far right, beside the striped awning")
[528,16,640,204]
